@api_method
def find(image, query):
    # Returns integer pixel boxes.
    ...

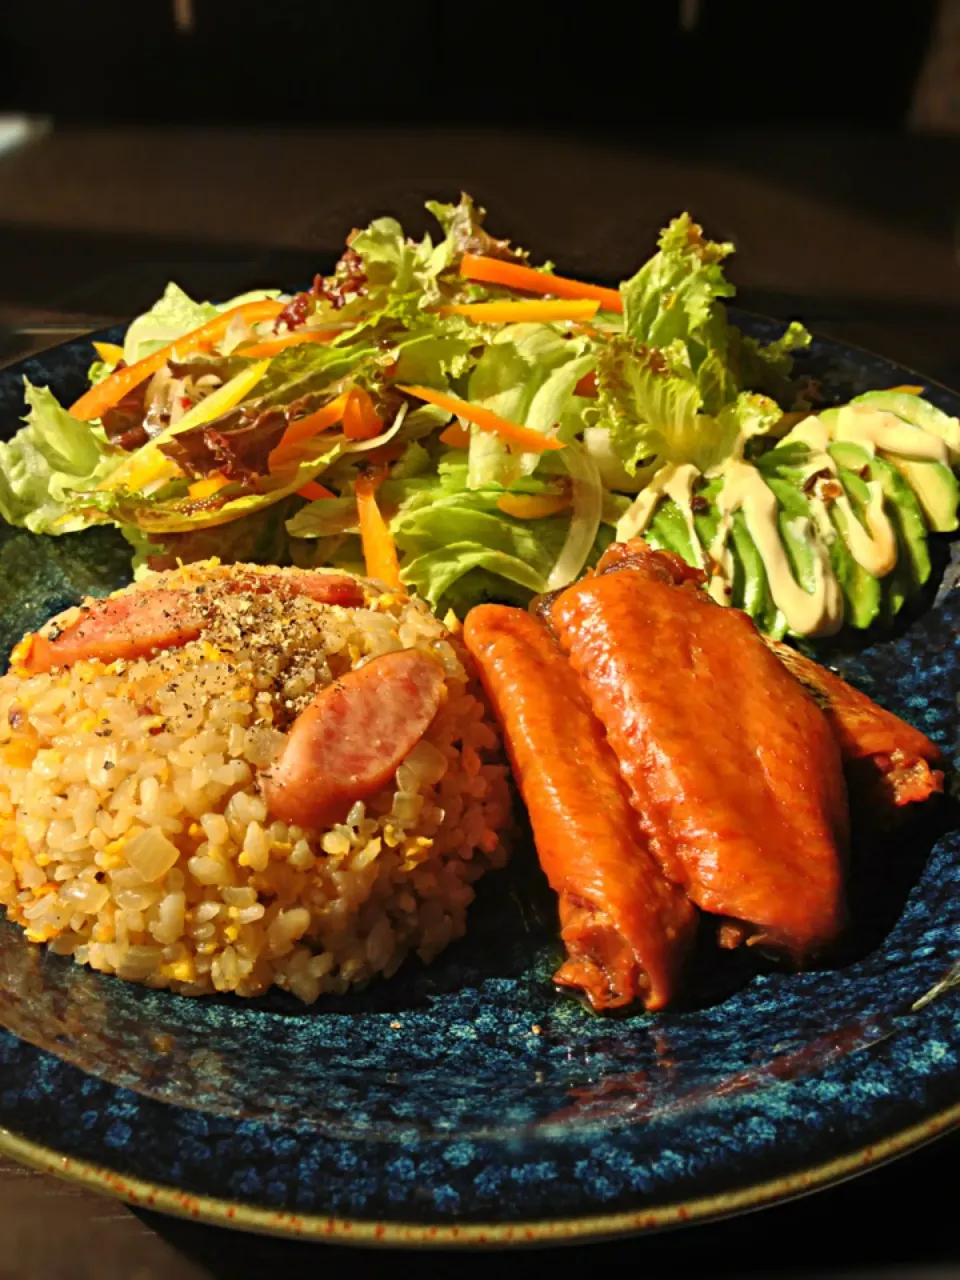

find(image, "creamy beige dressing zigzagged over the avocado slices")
[617,404,950,636]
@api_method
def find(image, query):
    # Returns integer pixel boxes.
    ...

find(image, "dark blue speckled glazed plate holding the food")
[0,317,960,1245]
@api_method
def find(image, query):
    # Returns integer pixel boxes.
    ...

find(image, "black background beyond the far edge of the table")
[0,0,936,137]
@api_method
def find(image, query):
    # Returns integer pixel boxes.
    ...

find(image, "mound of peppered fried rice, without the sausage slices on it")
[0,562,509,1002]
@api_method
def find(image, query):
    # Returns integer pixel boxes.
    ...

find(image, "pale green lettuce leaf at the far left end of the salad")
[0,379,124,534]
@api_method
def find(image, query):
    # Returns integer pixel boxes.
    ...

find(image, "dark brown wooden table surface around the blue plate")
[0,122,960,1280]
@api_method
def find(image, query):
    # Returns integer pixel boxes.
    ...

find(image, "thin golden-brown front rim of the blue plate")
[0,1102,960,1249]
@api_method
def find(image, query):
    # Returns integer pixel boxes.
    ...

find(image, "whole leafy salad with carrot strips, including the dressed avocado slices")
[0,196,960,636]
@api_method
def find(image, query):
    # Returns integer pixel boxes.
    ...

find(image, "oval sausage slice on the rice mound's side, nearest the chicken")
[264,649,444,827]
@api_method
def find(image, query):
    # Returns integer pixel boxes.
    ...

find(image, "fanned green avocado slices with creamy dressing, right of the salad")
[617,393,960,636]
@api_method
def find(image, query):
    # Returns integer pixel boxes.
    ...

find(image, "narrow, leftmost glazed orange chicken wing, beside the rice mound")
[463,604,696,1009]
